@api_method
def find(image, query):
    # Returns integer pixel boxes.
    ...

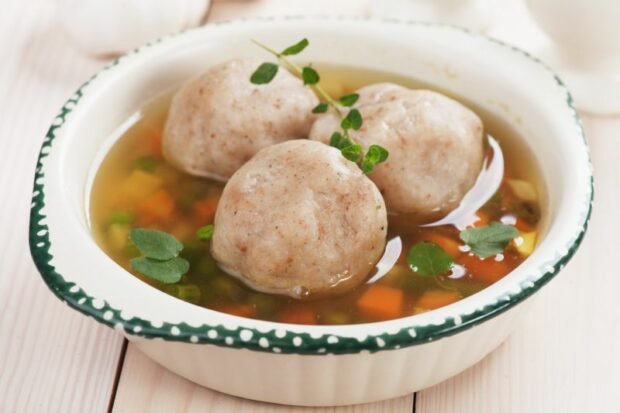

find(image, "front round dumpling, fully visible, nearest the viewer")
[211,140,387,298]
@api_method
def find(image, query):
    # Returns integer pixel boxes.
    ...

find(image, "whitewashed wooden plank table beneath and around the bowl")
[0,0,620,413]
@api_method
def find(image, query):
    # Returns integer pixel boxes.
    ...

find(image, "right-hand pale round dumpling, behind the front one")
[310,83,484,218]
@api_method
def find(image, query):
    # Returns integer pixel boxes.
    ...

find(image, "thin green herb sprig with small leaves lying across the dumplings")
[250,39,389,174]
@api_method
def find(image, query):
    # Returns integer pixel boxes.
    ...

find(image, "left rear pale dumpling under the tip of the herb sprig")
[162,59,318,179]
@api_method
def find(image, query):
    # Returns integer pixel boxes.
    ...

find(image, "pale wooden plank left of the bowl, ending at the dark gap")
[0,1,123,413]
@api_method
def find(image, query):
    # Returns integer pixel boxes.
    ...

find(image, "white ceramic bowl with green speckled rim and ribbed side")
[30,18,592,405]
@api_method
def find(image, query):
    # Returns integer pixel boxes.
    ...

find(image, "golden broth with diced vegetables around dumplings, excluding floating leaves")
[90,66,542,324]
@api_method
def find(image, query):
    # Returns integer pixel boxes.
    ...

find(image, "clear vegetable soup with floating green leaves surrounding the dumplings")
[90,65,543,325]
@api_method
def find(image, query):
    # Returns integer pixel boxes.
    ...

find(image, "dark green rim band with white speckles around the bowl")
[29,16,594,355]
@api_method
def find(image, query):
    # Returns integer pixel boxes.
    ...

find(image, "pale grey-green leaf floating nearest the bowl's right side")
[460,222,519,258]
